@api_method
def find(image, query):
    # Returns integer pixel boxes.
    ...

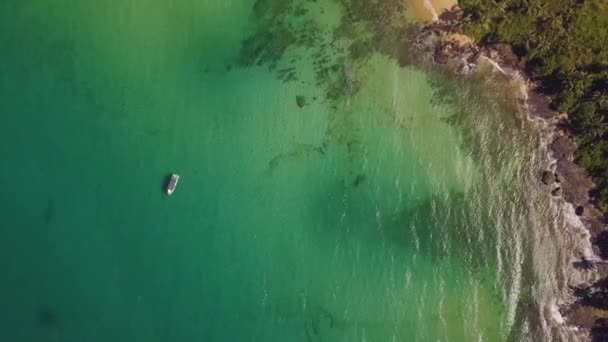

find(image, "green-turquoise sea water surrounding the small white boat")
[0,0,584,342]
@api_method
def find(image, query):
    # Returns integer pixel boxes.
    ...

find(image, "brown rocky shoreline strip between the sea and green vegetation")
[414,7,608,341]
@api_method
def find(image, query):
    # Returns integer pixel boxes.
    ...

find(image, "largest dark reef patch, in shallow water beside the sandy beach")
[237,0,417,101]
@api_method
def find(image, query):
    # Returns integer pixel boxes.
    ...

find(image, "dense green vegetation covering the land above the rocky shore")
[459,0,608,212]
